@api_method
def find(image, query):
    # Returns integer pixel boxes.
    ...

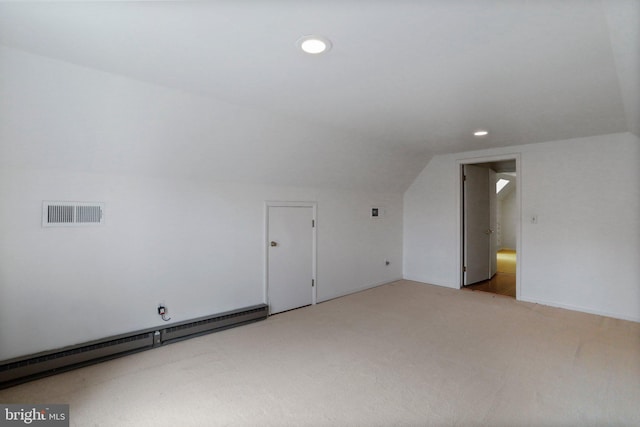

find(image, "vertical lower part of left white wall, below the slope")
[0,168,402,360]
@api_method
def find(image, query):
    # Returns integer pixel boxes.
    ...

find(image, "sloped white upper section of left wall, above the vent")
[0,46,426,192]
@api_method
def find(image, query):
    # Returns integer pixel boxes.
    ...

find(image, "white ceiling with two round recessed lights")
[0,0,640,190]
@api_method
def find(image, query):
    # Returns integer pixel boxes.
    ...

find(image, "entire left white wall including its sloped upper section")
[0,47,404,360]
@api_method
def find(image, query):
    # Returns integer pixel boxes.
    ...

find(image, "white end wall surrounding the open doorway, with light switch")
[403,133,640,321]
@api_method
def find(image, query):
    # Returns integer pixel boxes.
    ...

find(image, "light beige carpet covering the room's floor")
[0,281,640,426]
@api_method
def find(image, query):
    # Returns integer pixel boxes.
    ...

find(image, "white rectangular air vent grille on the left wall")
[42,201,104,227]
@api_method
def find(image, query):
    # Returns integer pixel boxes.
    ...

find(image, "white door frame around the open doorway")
[456,153,526,300]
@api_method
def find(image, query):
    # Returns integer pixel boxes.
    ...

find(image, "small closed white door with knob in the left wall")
[267,206,313,314]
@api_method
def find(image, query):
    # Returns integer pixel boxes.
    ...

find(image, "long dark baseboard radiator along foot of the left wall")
[0,304,269,389]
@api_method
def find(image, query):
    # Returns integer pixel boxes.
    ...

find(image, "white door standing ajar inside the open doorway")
[463,165,495,286]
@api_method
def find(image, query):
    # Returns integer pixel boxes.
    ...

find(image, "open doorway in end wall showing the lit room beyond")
[461,159,519,298]
